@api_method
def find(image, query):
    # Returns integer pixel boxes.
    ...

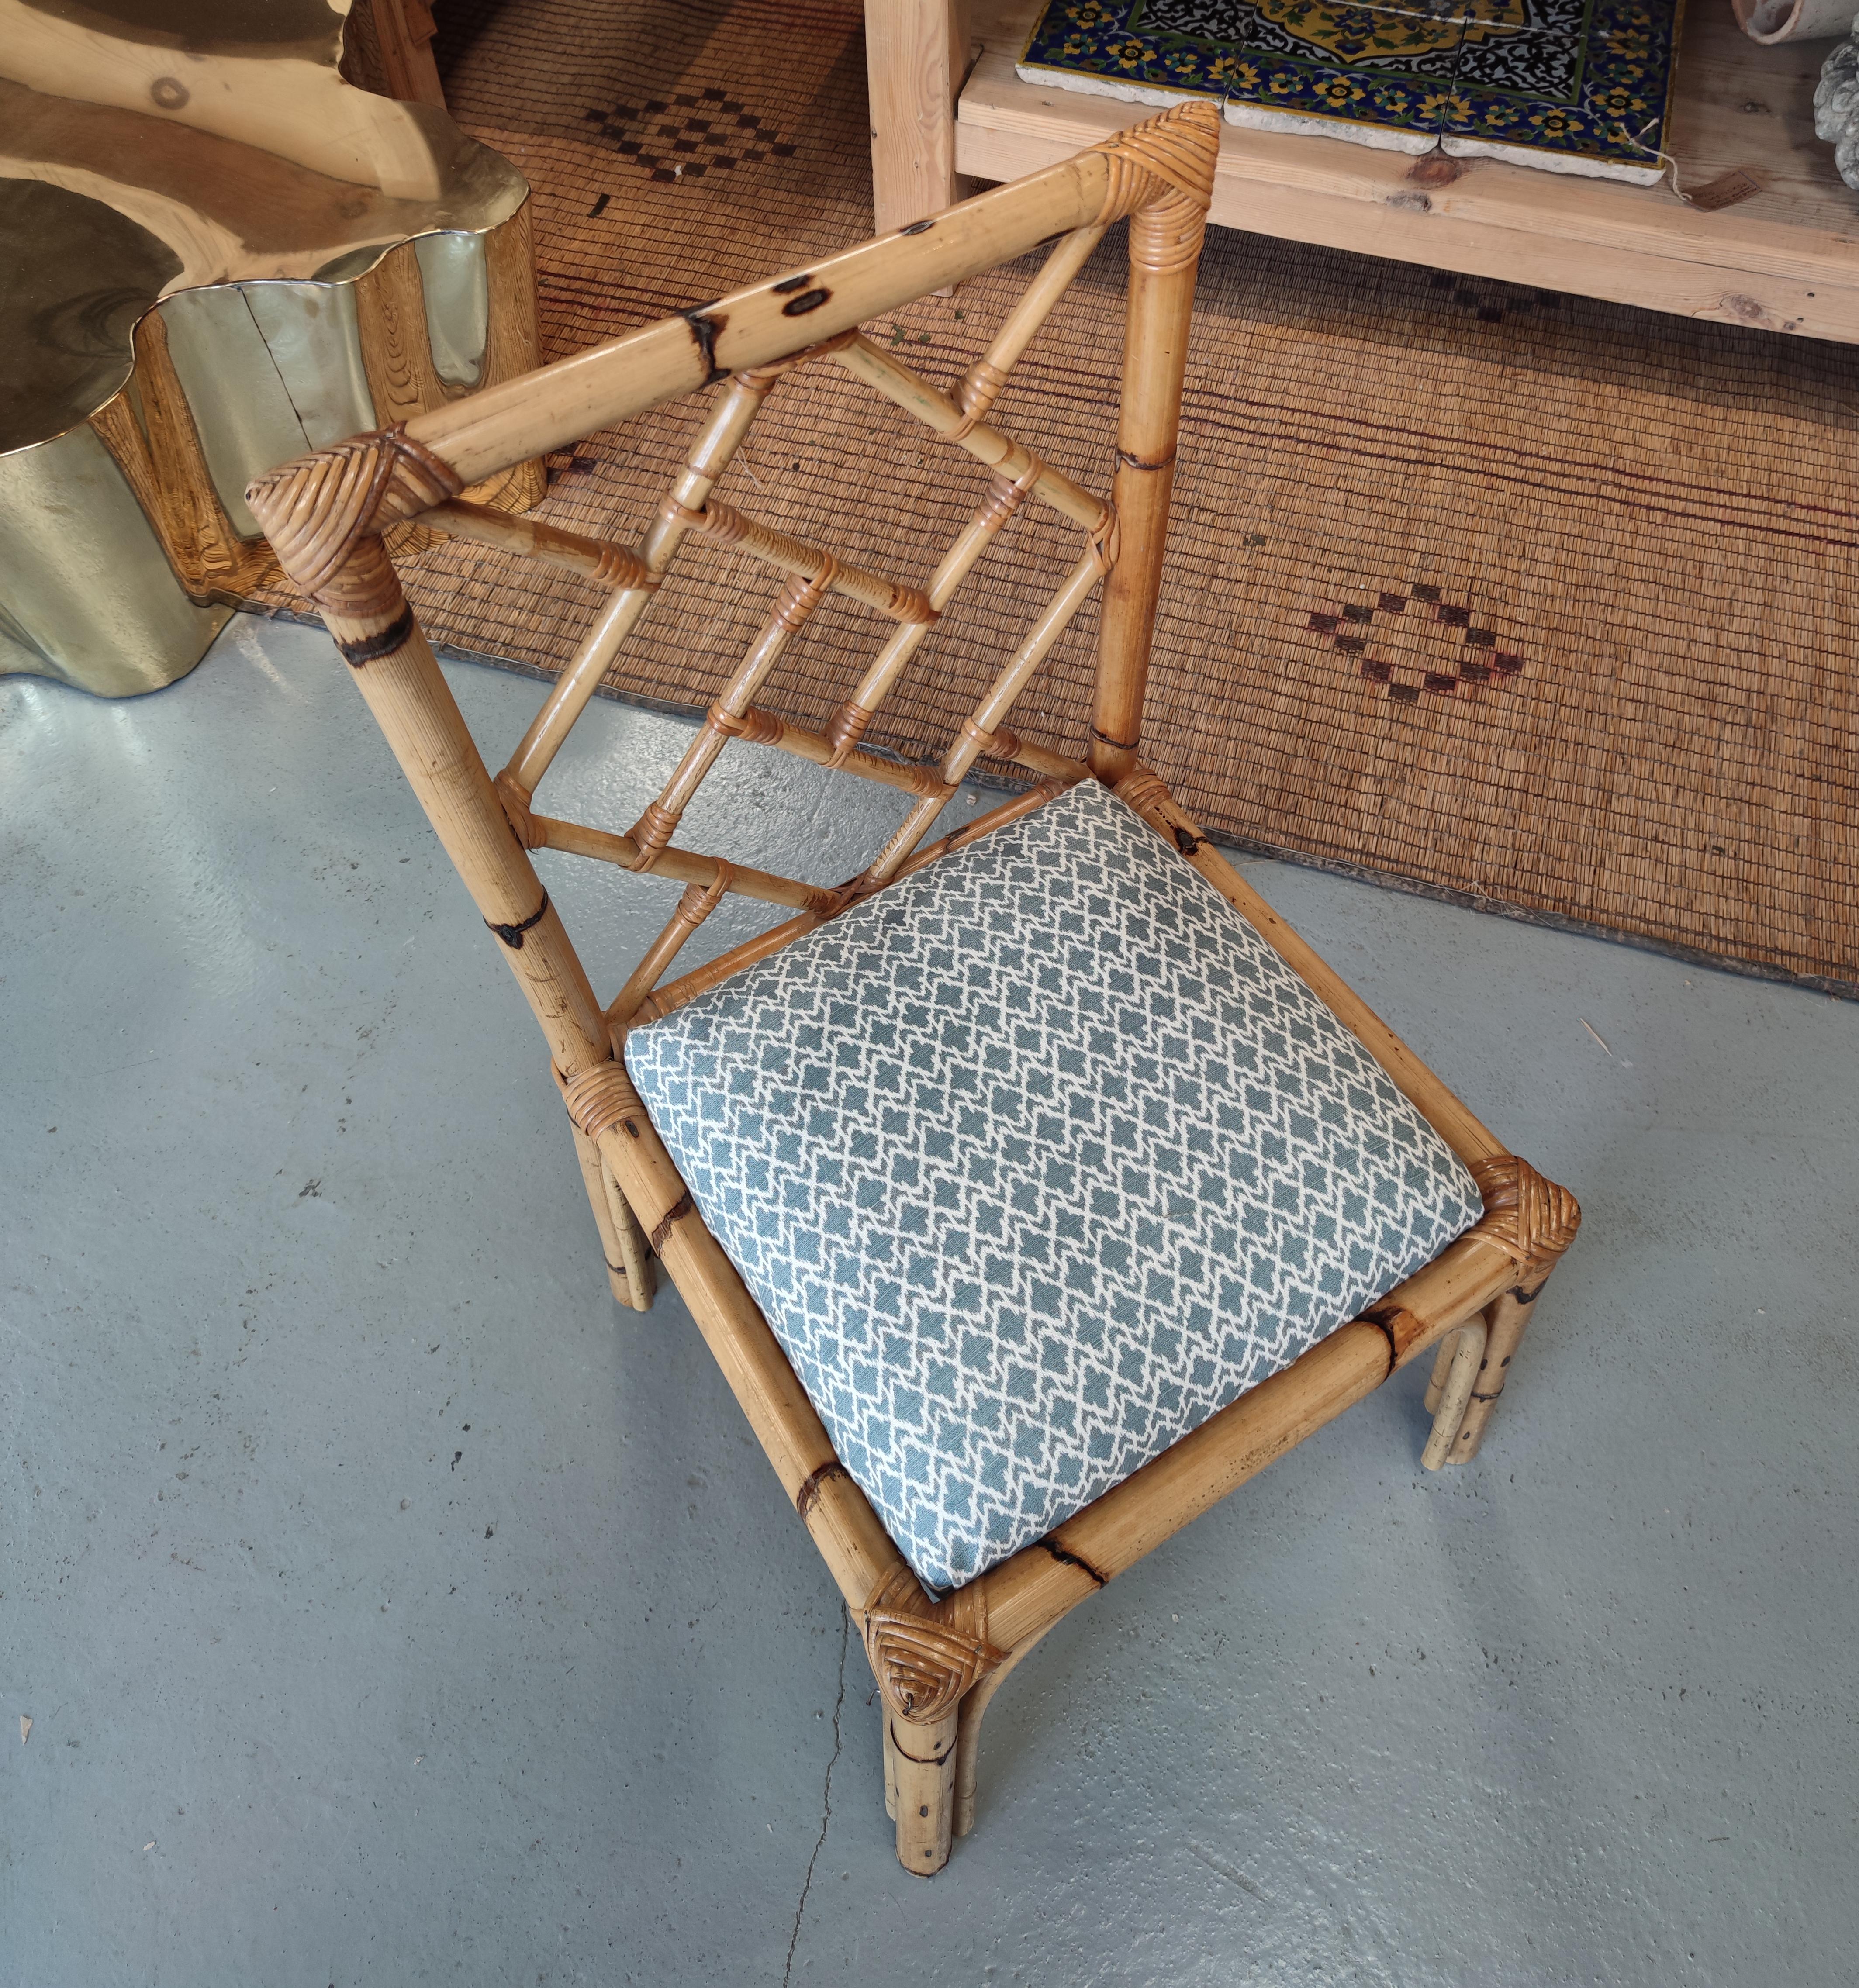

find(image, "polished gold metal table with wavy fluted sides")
[0,0,535,696]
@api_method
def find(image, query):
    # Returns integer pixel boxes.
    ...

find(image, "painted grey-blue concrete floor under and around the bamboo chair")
[0,620,1859,1988]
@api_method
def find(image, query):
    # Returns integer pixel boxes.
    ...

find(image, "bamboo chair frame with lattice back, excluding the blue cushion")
[249,105,1579,1875]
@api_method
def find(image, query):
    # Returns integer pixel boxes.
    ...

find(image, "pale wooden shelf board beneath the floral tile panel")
[956,0,1859,344]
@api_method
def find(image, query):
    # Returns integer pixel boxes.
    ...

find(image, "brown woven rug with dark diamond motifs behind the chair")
[264,0,1859,994]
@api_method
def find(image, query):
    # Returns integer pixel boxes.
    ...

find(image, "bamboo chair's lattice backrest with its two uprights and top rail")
[249,104,1219,1085]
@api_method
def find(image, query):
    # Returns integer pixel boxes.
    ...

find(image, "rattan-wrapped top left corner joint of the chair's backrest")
[245,421,465,620]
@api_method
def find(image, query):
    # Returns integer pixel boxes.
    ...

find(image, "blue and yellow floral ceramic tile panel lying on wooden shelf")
[1020,0,1682,181]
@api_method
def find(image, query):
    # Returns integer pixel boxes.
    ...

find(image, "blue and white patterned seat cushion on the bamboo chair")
[626,781,1483,1588]
